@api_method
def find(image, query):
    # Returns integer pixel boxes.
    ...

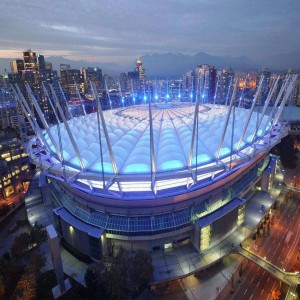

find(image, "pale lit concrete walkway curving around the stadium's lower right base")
[152,191,275,282]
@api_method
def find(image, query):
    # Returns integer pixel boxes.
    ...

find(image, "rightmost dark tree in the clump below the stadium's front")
[129,249,153,289]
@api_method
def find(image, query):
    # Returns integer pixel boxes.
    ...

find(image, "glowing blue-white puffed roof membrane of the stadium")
[45,103,268,174]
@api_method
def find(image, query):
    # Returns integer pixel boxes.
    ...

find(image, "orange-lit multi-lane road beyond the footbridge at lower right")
[251,192,300,272]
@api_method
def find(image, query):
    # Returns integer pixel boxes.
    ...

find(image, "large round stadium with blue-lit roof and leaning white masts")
[15,76,295,260]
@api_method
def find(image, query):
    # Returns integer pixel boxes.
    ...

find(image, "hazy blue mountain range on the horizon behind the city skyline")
[0,51,300,79]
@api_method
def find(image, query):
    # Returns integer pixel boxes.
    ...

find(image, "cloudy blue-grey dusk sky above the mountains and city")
[0,0,300,63]
